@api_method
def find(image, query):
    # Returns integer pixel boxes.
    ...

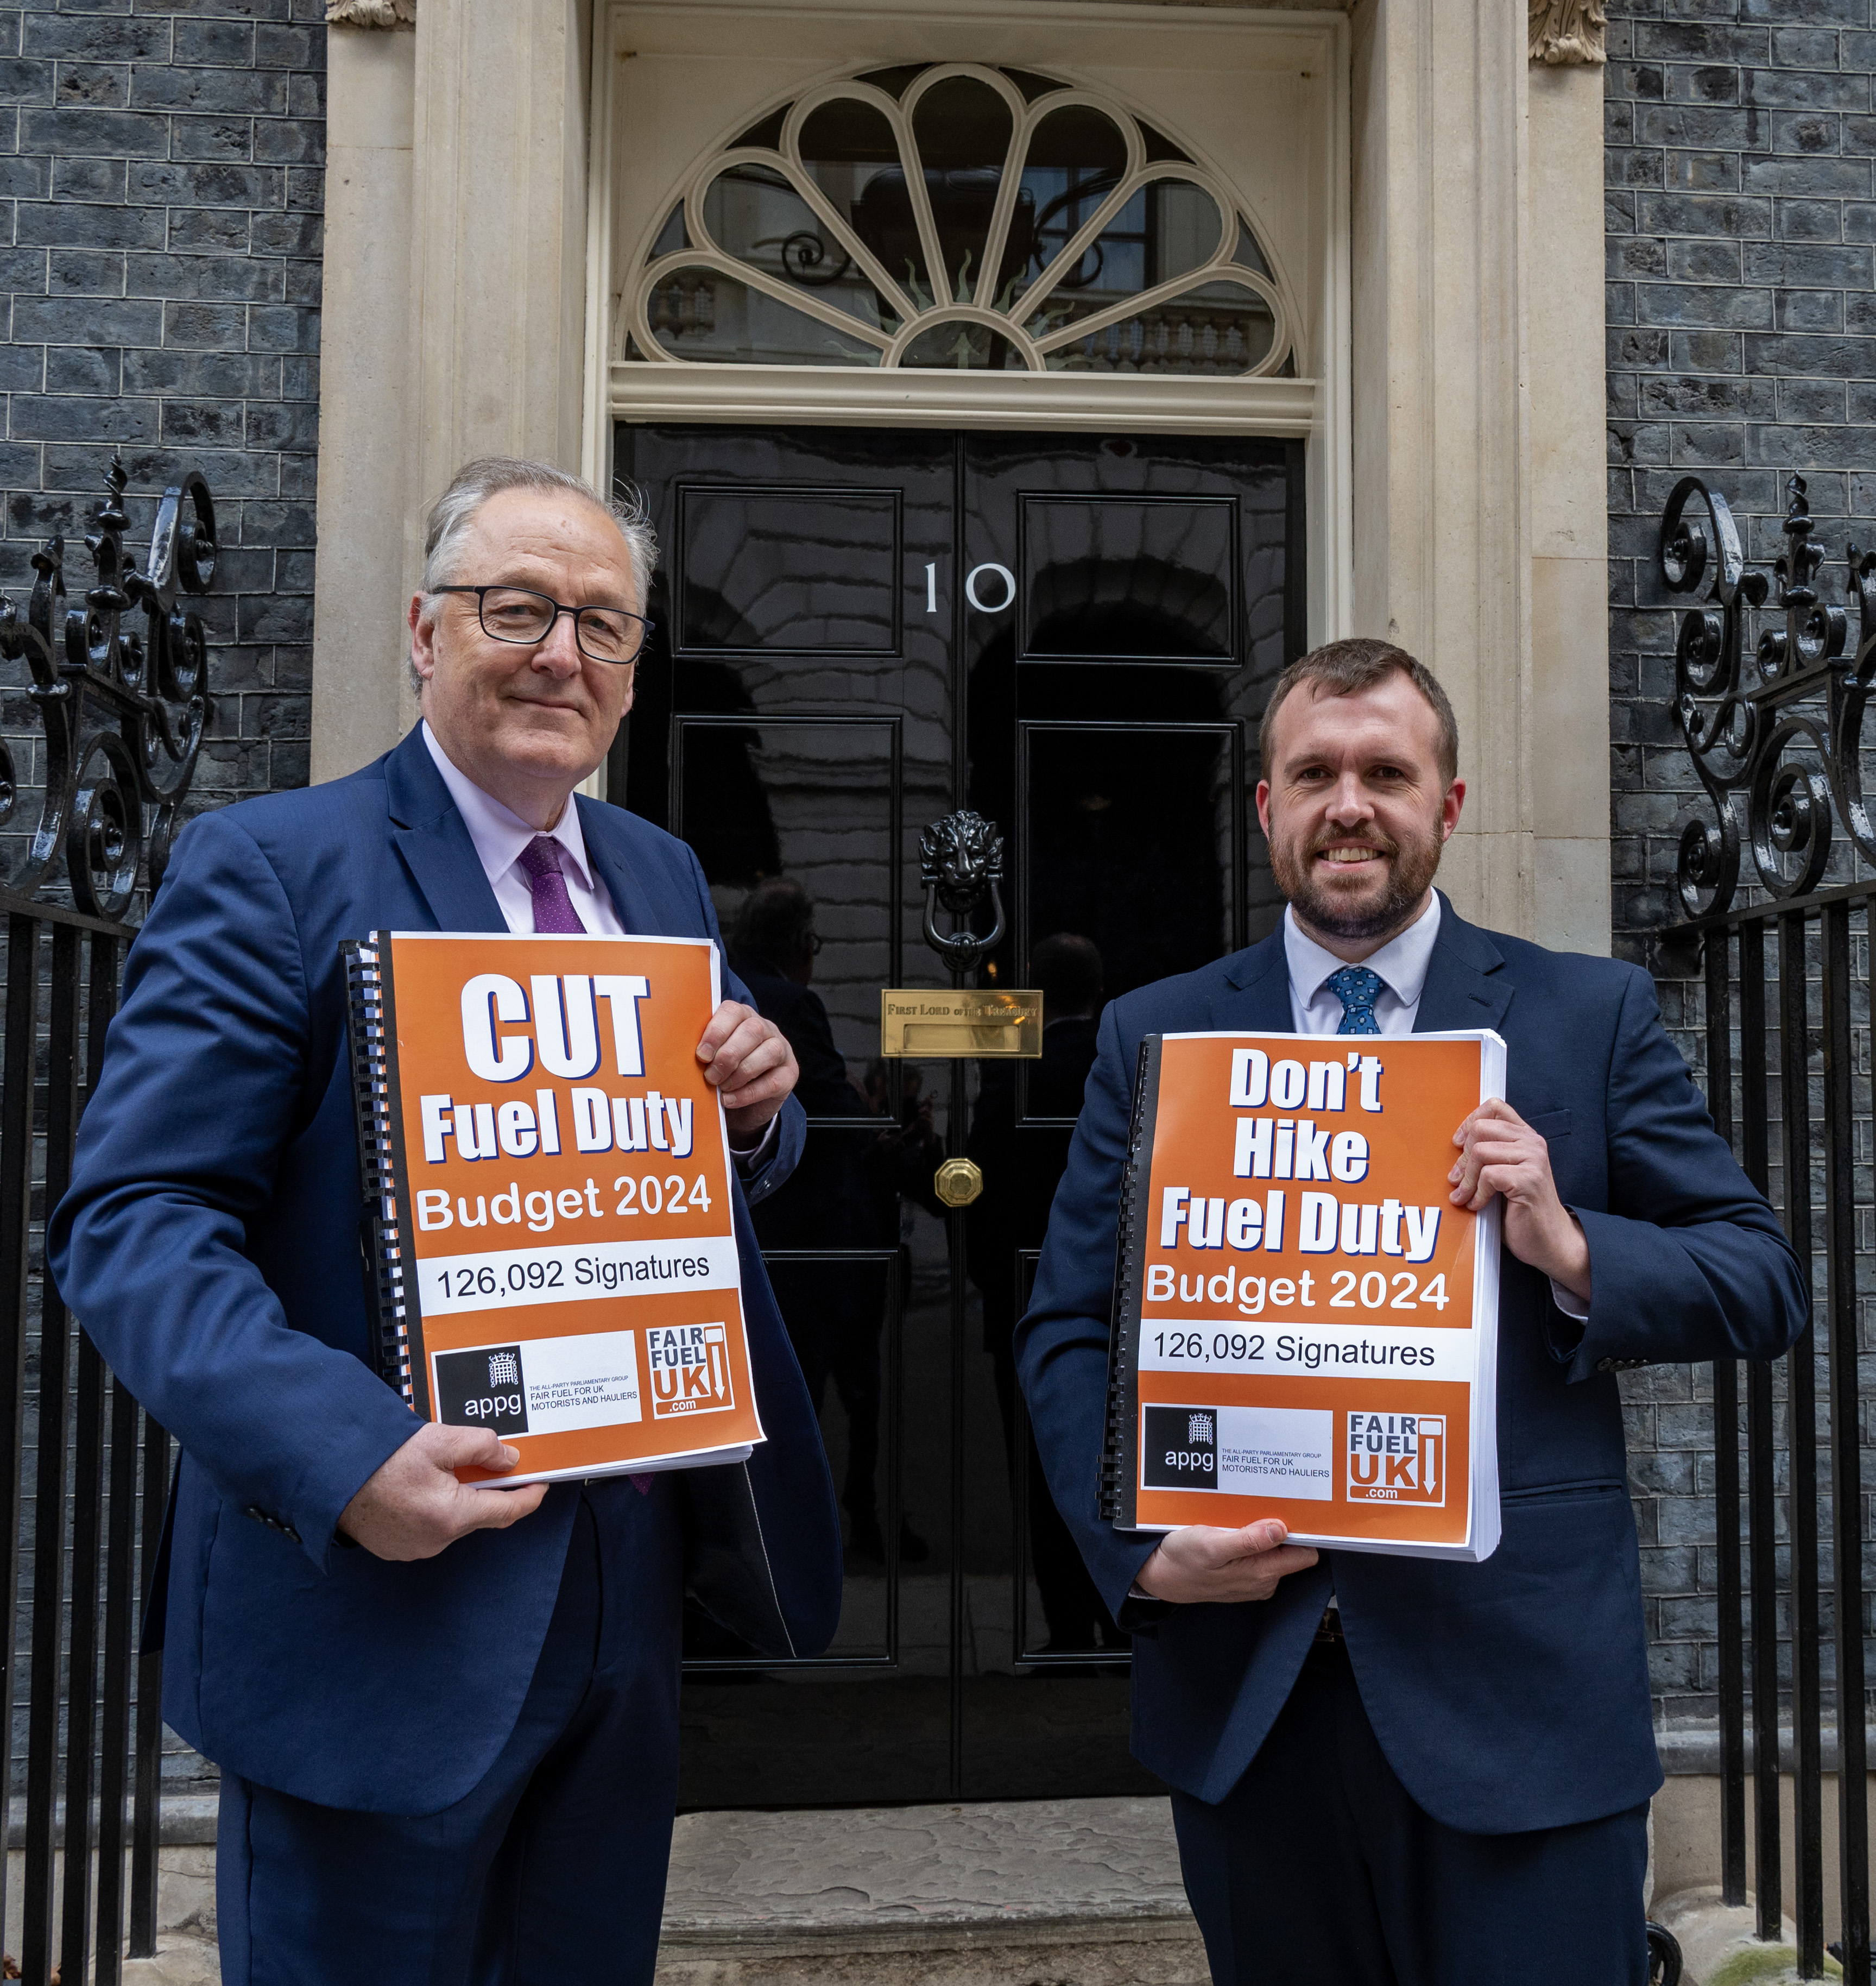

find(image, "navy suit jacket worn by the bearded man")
[1016,900,1806,1833]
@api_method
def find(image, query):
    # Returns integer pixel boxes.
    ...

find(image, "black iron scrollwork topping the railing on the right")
[1659,477,1876,918]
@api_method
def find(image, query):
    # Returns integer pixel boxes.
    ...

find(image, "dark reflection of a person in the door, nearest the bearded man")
[965,931,1128,1654]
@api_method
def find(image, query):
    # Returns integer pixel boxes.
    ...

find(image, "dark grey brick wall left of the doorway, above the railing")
[0,0,326,806]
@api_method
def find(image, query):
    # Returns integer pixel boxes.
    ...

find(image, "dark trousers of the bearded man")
[1173,1642,1648,1986]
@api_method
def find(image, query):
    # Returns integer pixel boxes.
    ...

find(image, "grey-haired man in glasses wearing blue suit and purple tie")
[48,461,840,1986]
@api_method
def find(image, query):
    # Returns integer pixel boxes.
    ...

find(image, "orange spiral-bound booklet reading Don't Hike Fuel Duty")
[1102,1031,1505,1561]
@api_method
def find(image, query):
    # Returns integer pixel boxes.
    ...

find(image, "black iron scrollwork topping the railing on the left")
[0,455,214,918]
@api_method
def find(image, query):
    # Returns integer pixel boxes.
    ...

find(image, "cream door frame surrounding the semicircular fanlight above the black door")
[582,0,1354,671]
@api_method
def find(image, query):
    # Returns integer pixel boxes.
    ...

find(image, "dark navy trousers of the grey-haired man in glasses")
[214,1476,683,1986]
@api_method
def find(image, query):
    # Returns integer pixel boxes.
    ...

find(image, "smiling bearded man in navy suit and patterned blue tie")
[1016,641,1806,1986]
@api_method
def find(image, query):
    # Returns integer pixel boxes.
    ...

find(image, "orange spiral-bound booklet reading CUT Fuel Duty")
[345,931,762,1484]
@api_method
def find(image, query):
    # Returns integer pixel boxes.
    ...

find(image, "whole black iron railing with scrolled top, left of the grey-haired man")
[0,463,214,1986]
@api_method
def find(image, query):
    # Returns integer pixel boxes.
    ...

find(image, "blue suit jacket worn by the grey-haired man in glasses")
[48,731,842,1813]
